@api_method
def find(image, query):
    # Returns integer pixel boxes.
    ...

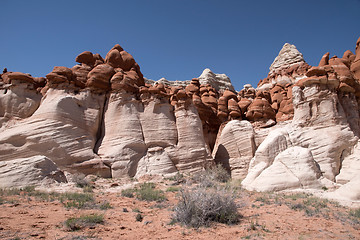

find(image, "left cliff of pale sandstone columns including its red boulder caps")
[0,45,214,182]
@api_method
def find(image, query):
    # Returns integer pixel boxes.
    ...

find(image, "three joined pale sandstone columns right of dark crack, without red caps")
[98,91,212,178]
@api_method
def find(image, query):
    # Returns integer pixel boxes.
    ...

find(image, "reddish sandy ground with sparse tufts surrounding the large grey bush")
[0,178,360,240]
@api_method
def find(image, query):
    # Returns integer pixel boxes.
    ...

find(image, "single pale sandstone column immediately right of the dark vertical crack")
[97,91,146,177]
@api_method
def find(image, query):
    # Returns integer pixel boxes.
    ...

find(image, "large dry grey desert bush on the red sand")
[173,188,240,228]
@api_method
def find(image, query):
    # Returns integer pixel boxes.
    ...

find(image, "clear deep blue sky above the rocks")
[0,0,360,90]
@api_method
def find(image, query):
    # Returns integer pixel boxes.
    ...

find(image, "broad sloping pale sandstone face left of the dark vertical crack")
[0,89,105,167]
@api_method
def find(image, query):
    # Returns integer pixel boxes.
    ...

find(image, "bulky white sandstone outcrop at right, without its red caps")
[242,81,360,194]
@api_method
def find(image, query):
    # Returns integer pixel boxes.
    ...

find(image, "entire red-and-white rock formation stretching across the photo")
[0,39,360,204]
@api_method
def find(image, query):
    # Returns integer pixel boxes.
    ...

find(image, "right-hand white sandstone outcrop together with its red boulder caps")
[242,38,360,201]
